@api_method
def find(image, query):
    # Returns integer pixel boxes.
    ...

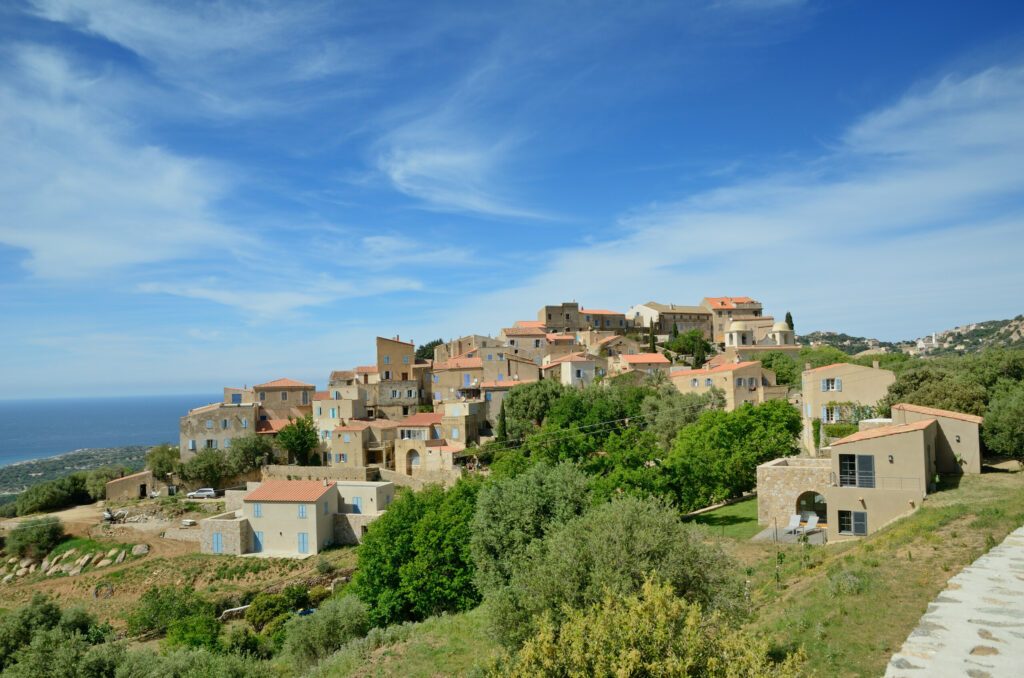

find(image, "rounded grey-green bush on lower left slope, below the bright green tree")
[285,595,370,666]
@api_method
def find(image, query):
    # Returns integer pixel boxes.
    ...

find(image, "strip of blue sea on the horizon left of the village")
[0,394,221,466]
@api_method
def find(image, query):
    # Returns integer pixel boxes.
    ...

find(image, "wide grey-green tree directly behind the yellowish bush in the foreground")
[488,497,746,647]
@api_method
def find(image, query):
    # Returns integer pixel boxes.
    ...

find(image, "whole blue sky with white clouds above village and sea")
[0,0,1024,396]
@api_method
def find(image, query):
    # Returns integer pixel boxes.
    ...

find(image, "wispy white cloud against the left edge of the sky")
[0,45,241,279]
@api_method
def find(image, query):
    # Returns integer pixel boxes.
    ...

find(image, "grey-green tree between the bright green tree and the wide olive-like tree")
[470,464,590,594]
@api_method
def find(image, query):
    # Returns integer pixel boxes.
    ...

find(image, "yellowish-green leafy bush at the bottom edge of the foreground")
[488,578,806,678]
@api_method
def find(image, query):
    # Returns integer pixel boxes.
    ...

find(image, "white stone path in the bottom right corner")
[886,527,1024,678]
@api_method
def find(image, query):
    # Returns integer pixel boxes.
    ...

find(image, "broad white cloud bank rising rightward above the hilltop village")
[436,65,1024,338]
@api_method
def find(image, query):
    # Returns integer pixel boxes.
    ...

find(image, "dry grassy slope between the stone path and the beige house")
[751,473,1024,676]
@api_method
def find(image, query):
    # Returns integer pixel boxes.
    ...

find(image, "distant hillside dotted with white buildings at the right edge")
[797,315,1024,355]
